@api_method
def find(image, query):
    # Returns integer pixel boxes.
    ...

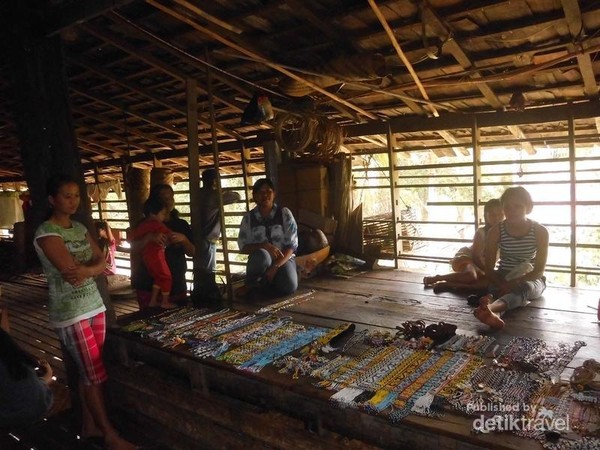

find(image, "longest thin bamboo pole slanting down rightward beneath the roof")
[146,0,377,120]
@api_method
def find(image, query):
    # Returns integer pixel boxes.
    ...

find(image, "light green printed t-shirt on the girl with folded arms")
[33,221,106,328]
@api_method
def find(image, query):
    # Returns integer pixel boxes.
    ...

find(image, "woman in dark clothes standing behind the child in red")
[131,184,196,309]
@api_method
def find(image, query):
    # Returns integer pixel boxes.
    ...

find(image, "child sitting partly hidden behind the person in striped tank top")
[423,198,504,294]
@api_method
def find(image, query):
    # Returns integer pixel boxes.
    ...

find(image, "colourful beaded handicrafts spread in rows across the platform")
[123,308,600,449]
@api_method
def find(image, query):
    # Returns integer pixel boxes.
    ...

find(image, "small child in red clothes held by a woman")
[131,198,177,309]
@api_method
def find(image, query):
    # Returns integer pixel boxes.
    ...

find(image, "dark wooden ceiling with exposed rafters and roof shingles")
[0,0,600,182]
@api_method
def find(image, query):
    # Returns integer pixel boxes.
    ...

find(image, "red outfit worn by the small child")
[131,219,173,293]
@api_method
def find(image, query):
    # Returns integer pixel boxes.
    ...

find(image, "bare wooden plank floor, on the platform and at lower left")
[0,270,600,449]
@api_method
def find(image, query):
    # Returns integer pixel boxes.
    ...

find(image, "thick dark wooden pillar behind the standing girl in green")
[9,36,92,264]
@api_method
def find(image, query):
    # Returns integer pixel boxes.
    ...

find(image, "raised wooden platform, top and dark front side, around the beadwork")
[103,270,600,449]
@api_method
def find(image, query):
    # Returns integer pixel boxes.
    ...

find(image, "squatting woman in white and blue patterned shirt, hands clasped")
[236,178,298,296]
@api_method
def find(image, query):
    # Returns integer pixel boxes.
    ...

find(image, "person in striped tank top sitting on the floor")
[473,186,548,329]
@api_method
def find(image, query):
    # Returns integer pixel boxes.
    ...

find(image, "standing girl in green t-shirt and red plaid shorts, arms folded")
[34,175,136,450]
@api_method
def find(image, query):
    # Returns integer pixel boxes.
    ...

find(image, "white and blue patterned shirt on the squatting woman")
[238,205,298,252]
